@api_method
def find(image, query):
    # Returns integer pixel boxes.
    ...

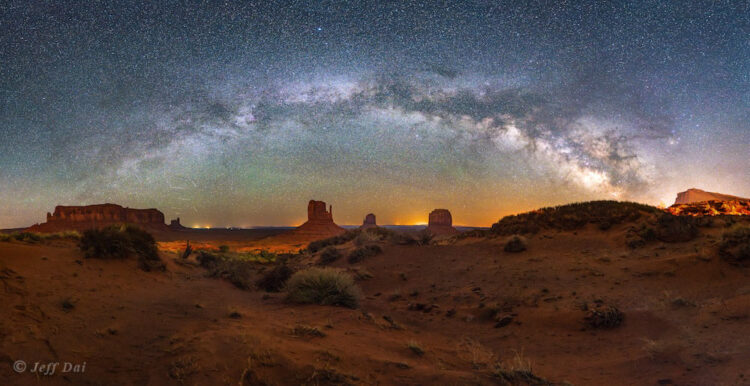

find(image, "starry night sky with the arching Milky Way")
[0,0,750,228]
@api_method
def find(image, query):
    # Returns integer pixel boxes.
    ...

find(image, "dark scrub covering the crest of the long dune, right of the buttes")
[490,201,661,235]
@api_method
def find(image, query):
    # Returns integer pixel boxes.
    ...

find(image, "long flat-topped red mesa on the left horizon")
[28,204,167,232]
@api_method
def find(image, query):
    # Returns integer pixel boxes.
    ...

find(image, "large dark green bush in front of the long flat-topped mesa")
[79,225,165,271]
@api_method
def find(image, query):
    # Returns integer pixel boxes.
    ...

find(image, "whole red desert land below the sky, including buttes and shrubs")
[0,193,750,385]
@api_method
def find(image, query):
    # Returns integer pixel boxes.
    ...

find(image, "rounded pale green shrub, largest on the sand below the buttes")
[287,268,362,308]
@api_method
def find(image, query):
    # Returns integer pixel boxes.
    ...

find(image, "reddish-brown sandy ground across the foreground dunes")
[0,226,750,385]
